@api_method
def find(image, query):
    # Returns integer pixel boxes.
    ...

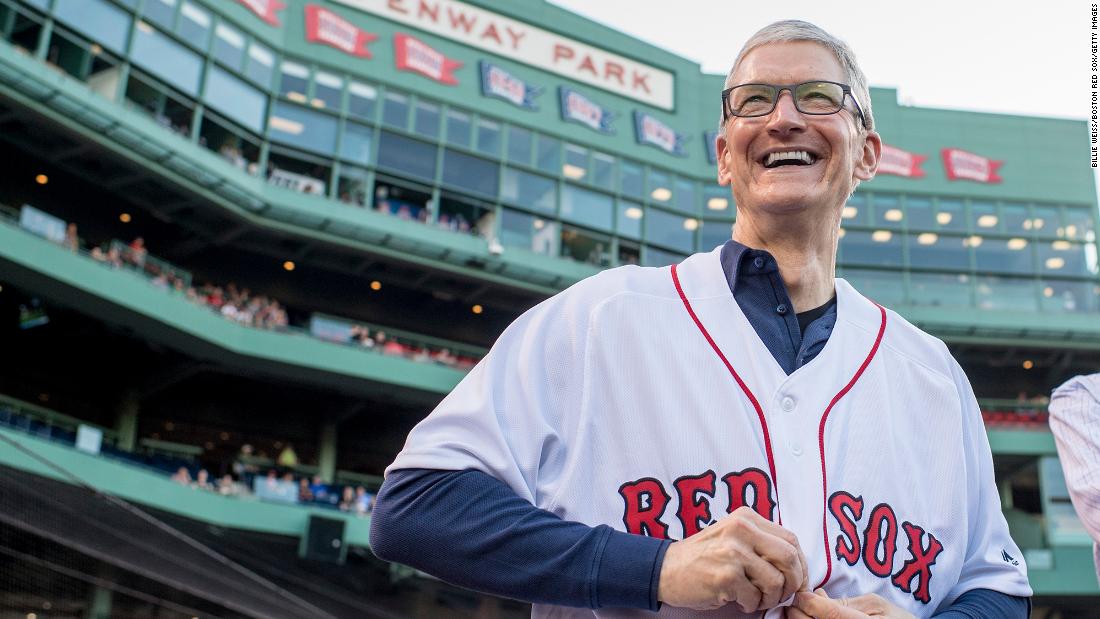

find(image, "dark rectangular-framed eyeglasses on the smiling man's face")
[722,80,870,129]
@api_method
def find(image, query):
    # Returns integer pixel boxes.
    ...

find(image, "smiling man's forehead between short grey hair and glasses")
[733,41,847,85]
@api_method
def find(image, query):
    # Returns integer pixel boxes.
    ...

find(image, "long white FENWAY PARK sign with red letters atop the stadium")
[334,0,673,110]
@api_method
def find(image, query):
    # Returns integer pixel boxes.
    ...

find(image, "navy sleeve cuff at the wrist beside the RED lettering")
[593,530,672,610]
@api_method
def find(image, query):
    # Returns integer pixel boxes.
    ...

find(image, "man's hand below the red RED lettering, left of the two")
[657,507,810,612]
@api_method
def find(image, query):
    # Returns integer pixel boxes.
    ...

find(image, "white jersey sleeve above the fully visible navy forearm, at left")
[386,276,600,505]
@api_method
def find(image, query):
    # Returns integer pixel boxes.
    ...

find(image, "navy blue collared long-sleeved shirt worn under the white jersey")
[371,241,1031,619]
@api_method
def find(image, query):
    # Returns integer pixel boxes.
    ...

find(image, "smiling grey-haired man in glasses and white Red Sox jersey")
[371,21,1031,619]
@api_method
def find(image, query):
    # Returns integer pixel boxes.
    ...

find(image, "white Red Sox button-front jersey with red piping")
[387,248,1031,617]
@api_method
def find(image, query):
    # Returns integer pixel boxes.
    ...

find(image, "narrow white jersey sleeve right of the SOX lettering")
[941,351,1032,608]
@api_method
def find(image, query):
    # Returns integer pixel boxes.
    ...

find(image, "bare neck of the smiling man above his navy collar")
[734,213,837,312]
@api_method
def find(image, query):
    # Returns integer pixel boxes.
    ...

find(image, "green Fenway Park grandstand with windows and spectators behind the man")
[0,0,1100,619]
